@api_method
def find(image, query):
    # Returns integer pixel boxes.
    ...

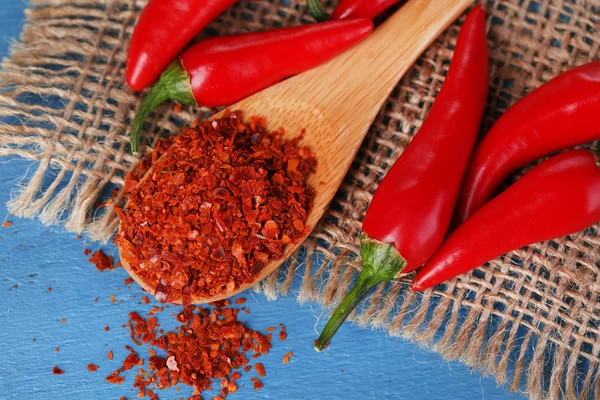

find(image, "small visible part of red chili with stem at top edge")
[307,0,400,21]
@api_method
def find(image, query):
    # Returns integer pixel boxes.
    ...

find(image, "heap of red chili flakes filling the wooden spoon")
[116,112,316,305]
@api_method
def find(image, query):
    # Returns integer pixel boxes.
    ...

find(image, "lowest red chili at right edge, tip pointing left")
[411,150,600,291]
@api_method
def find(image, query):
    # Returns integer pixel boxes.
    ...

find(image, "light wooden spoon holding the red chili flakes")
[119,0,473,303]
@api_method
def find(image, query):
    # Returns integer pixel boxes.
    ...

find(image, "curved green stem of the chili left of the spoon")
[129,61,196,155]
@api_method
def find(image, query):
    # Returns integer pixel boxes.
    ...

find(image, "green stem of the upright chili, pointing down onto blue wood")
[315,233,406,351]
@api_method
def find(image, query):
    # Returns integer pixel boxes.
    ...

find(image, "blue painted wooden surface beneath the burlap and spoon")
[0,0,521,400]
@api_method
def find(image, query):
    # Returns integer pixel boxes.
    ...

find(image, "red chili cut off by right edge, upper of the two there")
[453,61,600,226]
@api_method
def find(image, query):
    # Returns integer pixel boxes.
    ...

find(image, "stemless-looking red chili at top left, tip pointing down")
[125,0,237,91]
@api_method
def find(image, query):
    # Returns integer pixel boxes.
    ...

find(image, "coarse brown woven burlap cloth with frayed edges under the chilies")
[0,0,600,399]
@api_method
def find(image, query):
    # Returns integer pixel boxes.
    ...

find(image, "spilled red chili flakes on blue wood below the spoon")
[106,302,271,400]
